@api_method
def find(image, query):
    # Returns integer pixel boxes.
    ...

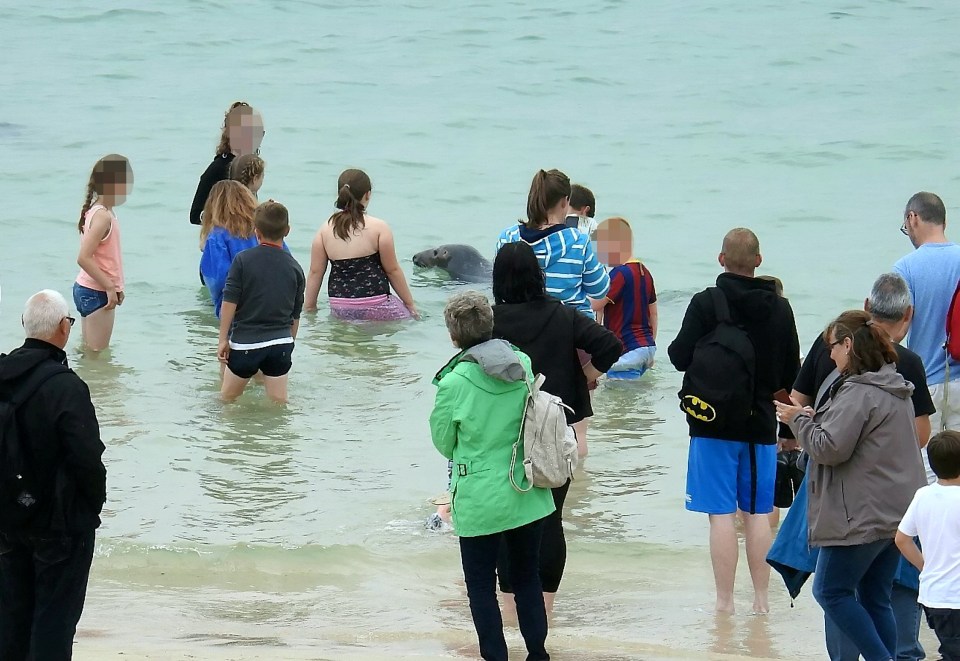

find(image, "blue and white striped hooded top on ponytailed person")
[497,225,610,318]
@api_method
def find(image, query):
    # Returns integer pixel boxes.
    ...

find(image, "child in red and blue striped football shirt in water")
[594,217,657,379]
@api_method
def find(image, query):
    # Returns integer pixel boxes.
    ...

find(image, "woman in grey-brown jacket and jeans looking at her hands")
[777,310,926,661]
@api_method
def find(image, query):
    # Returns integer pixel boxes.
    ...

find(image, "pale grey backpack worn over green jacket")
[510,374,578,492]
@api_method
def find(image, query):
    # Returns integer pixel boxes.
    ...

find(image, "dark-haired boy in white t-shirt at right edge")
[896,430,960,661]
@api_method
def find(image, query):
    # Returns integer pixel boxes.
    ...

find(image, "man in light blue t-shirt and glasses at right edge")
[893,192,960,482]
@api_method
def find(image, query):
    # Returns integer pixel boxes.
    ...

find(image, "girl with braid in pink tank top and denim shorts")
[73,154,133,351]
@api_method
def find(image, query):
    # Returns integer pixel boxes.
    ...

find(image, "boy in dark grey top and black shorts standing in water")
[217,200,306,402]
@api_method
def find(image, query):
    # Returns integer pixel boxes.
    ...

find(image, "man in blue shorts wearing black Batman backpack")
[667,228,800,613]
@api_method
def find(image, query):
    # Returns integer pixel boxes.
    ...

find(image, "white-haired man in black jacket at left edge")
[0,290,107,661]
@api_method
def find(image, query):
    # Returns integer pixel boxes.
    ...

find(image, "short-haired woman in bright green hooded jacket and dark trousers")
[430,291,554,661]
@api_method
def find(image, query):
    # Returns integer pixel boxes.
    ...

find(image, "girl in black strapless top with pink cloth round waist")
[306,170,420,321]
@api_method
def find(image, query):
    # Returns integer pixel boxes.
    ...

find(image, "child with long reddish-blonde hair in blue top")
[200,180,257,317]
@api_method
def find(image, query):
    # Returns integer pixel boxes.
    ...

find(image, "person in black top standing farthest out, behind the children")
[190,101,264,225]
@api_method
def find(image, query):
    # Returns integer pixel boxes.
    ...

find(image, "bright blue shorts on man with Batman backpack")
[687,436,777,514]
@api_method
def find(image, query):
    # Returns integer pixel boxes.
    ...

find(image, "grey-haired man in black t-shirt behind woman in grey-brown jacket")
[791,273,936,661]
